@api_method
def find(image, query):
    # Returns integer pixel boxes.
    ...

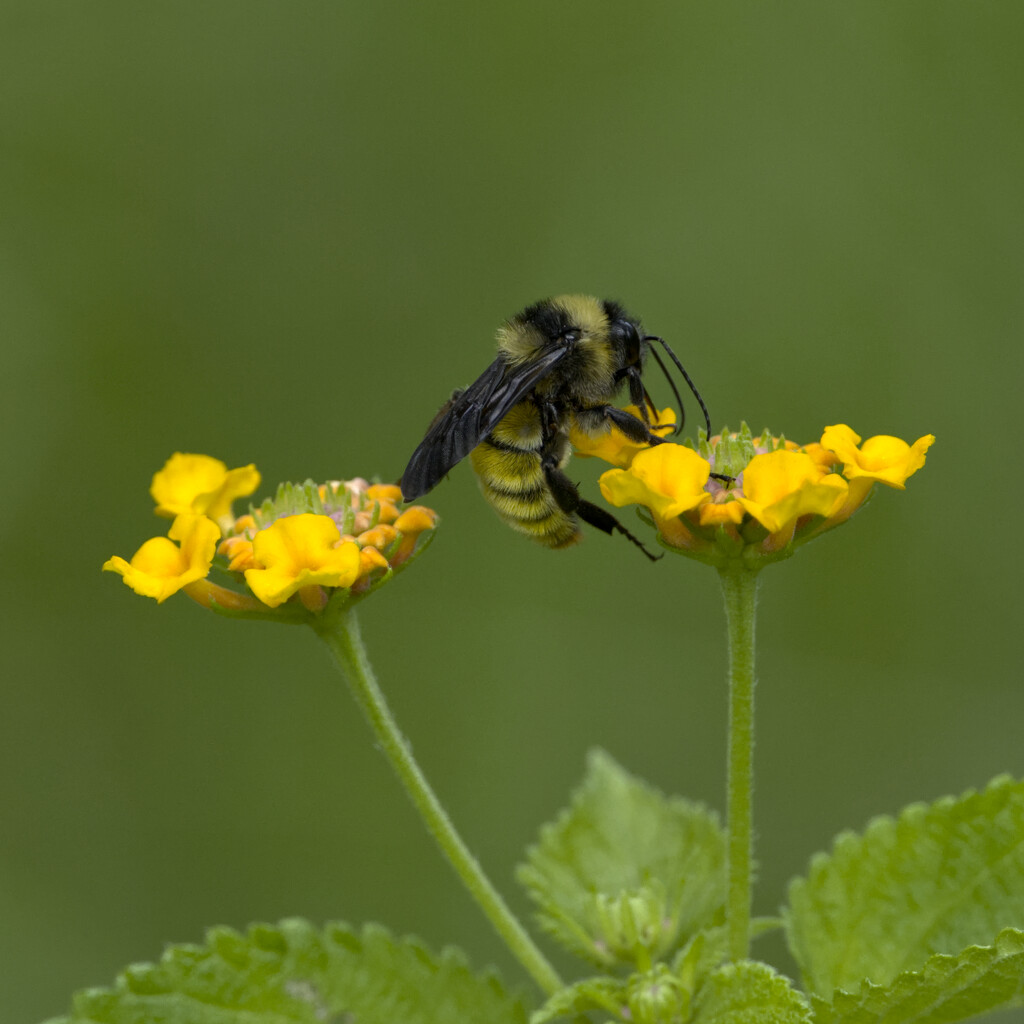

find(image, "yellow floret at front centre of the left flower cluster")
[245,512,359,608]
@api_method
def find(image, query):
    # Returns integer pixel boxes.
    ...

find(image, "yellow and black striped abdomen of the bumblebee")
[469,401,582,548]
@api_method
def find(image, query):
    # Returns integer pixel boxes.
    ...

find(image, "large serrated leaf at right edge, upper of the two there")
[785,777,1024,999]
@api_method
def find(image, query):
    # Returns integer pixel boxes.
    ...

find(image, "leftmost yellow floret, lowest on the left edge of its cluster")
[103,513,220,604]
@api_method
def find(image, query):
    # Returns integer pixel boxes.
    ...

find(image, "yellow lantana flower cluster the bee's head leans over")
[582,423,935,565]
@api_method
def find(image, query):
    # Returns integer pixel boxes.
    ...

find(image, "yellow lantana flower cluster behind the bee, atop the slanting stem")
[103,453,437,621]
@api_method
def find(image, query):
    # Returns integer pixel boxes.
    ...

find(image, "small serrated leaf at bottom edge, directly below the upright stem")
[692,961,812,1024]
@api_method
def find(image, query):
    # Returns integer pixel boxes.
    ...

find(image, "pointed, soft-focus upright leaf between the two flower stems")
[518,751,725,969]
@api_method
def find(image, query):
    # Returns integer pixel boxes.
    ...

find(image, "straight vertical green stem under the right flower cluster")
[719,565,758,961]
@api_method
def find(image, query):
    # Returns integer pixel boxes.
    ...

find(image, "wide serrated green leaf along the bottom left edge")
[50,920,526,1024]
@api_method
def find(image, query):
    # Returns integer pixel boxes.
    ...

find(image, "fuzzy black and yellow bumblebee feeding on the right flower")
[400,295,711,560]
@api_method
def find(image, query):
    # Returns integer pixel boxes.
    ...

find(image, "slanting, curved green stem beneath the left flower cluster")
[315,606,565,995]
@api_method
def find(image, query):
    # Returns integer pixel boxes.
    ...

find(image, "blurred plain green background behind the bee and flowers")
[0,0,1024,1022]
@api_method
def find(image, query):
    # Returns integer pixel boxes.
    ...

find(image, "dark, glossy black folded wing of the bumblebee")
[400,346,566,502]
